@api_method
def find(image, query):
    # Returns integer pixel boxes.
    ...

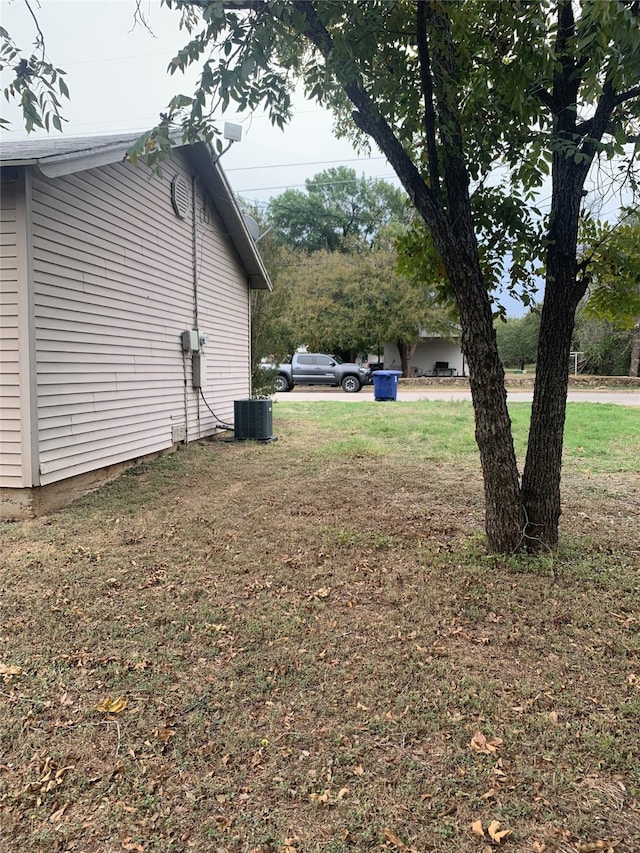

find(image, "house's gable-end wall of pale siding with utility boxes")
[26,153,249,485]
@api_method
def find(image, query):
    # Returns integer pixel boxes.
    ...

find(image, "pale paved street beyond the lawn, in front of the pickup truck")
[274,383,640,406]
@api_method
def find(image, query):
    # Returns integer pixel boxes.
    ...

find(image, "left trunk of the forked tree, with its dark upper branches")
[294,2,524,553]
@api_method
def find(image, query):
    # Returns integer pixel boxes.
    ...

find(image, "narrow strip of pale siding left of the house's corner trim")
[0,181,25,488]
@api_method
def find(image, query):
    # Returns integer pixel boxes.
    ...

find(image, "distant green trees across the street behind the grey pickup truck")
[252,166,640,381]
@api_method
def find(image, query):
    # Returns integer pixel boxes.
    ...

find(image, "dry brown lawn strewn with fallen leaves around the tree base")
[0,403,640,853]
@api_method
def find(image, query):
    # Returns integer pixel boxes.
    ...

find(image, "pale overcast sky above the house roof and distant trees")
[0,0,398,203]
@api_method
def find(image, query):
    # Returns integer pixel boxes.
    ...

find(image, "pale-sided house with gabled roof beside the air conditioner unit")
[0,134,270,517]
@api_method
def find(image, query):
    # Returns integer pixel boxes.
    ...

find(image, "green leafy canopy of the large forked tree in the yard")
[132,0,639,292]
